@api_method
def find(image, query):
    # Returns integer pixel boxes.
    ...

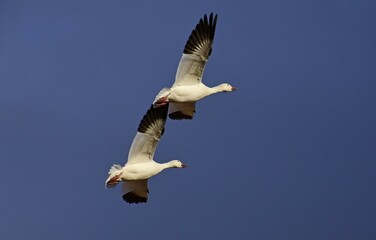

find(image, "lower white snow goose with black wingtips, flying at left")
[105,104,186,203]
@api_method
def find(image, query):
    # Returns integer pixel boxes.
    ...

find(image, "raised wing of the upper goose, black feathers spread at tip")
[174,13,217,86]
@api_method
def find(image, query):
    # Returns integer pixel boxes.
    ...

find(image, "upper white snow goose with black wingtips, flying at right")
[153,13,236,120]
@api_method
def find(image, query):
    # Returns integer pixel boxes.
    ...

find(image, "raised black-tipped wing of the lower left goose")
[127,104,168,164]
